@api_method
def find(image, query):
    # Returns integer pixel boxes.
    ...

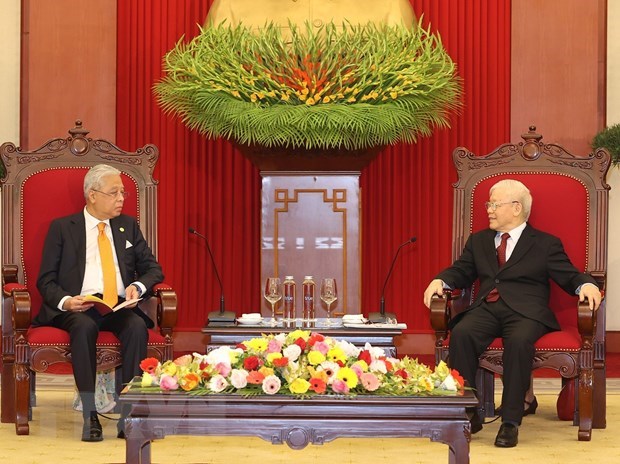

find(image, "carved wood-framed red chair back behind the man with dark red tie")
[452,127,610,339]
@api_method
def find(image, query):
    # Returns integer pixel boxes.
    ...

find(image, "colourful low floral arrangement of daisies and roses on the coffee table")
[133,330,464,397]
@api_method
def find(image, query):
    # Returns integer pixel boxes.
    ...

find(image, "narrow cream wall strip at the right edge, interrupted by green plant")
[606,0,620,330]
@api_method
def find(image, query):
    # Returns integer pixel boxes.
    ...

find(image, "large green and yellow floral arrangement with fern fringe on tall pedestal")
[154,21,461,150]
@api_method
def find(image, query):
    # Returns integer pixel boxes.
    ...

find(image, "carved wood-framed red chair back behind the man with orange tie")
[0,121,159,317]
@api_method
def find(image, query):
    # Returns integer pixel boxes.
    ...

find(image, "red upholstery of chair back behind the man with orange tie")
[19,166,139,318]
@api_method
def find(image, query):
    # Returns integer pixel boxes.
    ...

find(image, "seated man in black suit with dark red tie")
[424,179,601,447]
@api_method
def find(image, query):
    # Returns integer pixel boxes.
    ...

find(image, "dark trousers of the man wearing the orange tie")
[50,308,148,418]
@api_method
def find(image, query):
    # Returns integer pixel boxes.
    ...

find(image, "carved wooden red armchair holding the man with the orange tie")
[0,121,177,435]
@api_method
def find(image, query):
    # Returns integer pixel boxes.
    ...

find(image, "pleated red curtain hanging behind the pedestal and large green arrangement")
[117,0,510,332]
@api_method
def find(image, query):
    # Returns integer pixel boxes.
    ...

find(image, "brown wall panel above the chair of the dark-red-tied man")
[511,0,607,154]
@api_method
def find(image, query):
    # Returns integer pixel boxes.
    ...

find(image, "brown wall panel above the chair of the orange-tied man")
[20,0,116,149]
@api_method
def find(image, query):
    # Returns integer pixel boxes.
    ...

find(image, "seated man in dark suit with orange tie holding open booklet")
[33,164,164,441]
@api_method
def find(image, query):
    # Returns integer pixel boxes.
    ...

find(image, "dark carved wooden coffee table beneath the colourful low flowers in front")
[119,387,478,464]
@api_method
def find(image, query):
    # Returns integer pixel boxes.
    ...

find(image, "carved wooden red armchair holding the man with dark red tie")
[431,127,610,440]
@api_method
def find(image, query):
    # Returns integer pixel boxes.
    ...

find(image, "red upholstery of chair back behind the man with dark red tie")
[469,174,590,329]
